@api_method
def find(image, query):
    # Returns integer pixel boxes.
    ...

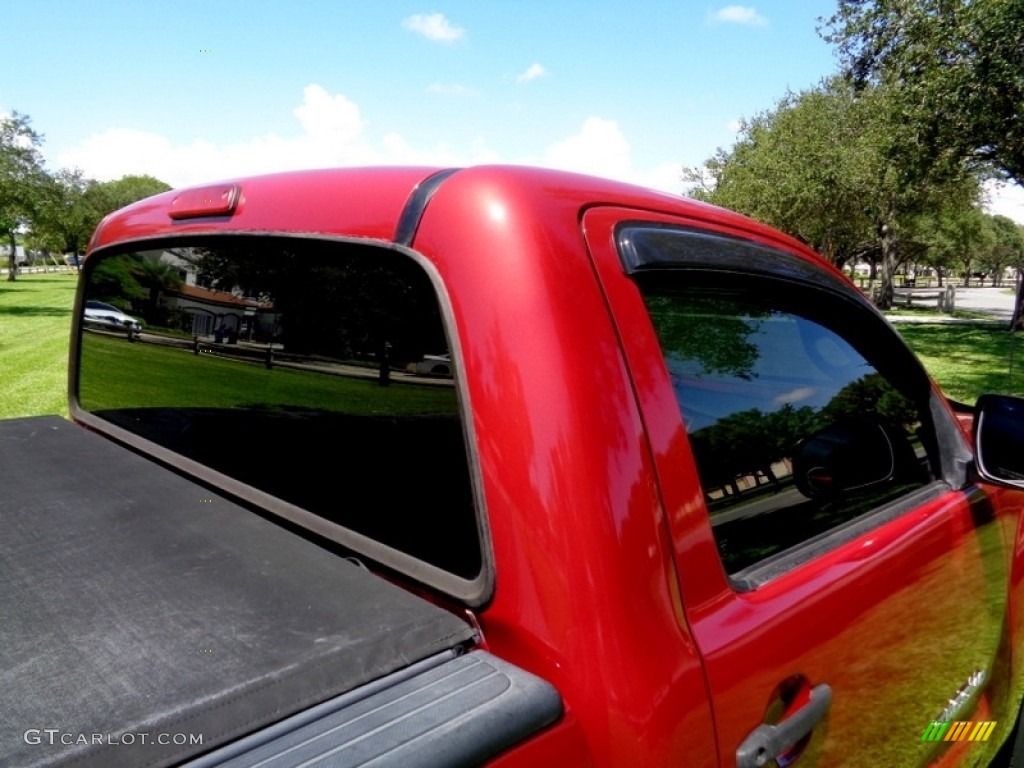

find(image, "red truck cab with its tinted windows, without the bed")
[8,167,1024,768]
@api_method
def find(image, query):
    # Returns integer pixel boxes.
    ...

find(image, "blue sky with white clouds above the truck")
[8,0,1024,221]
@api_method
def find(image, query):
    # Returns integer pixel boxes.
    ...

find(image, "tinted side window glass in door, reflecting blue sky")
[635,270,937,574]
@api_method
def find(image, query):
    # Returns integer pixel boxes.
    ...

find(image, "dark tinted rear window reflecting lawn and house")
[77,237,483,598]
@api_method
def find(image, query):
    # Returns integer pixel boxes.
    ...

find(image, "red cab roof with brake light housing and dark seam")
[89,166,810,260]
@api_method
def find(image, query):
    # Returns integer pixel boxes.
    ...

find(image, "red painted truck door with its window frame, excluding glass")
[585,201,1020,766]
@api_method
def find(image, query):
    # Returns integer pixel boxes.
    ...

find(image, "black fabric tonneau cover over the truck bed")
[0,417,479,768]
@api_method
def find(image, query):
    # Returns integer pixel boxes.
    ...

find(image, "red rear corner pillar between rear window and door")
[413,169,717,766]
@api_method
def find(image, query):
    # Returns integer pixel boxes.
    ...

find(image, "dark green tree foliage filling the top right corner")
[822,0,1024,321]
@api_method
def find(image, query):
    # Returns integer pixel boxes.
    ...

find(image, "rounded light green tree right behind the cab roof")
[684,78,980,308]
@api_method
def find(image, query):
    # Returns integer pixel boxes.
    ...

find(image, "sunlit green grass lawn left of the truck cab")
[0,272,78,419]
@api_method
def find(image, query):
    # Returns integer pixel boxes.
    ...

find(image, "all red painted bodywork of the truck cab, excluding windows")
[86,167,1024,768]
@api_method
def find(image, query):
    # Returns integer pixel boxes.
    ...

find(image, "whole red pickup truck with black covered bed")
[6,167,1024,768]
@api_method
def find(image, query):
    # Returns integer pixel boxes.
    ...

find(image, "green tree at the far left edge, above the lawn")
[0,112,47,281]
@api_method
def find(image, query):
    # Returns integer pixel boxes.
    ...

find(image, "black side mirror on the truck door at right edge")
[974,394,1024,489]
